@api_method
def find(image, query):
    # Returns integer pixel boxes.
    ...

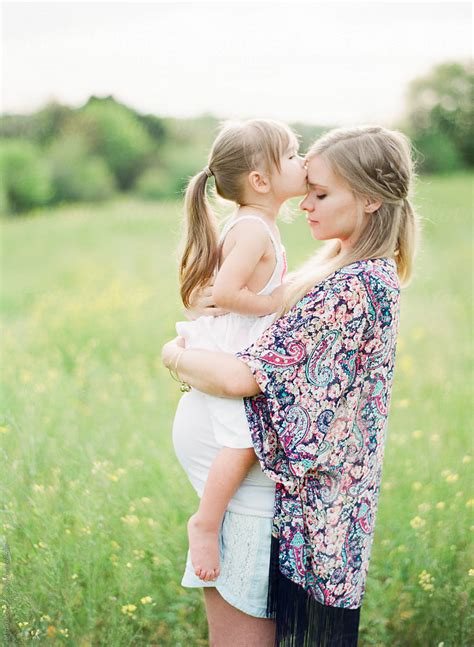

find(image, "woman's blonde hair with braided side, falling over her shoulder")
[279,126,420,315]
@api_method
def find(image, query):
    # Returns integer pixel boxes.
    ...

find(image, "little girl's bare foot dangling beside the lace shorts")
[188,513,220,582]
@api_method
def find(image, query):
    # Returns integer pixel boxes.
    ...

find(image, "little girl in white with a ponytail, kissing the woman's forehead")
[173,120,306,582]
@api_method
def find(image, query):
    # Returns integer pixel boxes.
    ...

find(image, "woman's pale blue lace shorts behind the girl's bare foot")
[181,511,272,618]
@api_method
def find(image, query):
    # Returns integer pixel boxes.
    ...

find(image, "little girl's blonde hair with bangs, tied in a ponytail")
[179,119,298,307]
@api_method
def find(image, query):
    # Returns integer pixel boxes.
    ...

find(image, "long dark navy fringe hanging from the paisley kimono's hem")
[267,536,360,647]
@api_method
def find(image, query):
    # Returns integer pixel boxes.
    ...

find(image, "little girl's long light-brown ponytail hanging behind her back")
[179,170,219,308]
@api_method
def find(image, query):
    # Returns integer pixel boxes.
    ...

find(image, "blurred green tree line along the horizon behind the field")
[0,62,474,214]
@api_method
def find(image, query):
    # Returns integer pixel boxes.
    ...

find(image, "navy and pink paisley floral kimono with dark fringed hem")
[238,258,400,647]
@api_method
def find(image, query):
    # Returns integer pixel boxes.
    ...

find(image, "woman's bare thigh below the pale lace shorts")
[204,587,275,647]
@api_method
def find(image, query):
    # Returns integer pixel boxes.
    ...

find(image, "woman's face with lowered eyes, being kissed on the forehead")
[300,155,368,249]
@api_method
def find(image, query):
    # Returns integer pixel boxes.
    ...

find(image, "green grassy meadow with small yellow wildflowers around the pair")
[0,175,474,647]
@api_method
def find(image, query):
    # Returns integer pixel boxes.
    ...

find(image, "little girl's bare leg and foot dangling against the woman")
[188,447,257,582]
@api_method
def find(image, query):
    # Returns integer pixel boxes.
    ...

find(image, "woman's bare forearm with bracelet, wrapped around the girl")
[162,337,260,398]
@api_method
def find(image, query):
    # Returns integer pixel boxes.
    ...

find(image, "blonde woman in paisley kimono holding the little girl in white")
[163,127,418,646]
